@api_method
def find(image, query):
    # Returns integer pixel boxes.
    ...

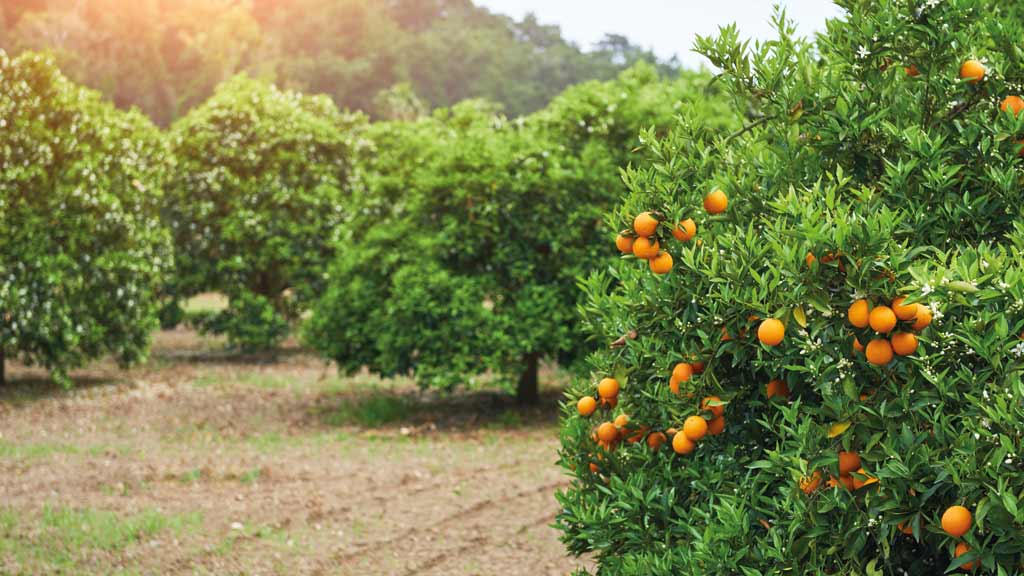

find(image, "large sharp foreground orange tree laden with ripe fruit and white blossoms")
[557,0,1024,575]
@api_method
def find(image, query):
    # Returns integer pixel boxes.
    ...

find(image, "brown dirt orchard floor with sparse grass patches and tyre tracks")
[0,317,581,575]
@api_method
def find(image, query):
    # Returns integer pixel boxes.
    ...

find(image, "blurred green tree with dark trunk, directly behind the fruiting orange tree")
[306,67,726,402]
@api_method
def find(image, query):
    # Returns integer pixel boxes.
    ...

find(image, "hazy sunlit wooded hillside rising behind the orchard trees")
[0,0,678,125]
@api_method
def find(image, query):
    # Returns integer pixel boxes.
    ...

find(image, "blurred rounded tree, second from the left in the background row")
[165,76,362,348]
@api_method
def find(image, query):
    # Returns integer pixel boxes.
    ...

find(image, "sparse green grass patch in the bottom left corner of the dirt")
[0,505,202,574]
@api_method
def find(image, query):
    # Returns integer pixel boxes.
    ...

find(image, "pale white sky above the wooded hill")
[477,0,841,68]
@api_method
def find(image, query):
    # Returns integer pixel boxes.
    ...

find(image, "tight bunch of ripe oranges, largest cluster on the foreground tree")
[846,296,932,366]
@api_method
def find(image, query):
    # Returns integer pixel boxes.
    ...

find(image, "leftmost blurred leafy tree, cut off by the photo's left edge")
[0,51,171,384]
